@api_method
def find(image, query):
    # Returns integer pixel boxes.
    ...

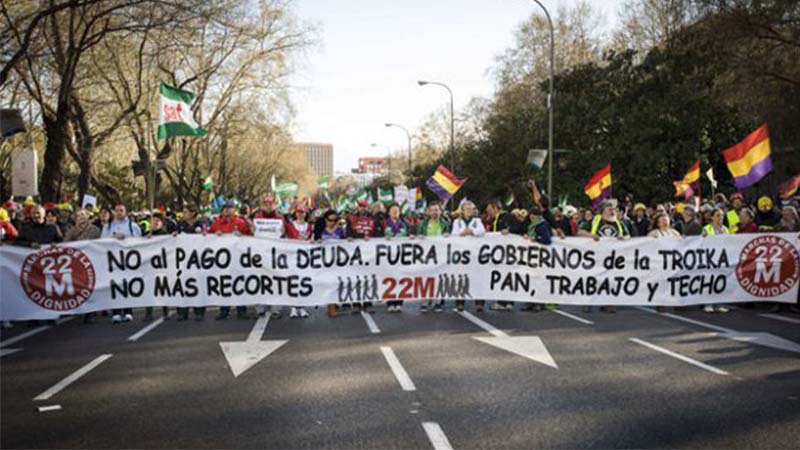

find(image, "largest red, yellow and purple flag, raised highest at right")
[722,124,772,190]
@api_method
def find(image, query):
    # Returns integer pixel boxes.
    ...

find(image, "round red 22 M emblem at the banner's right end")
[736,235,800,297]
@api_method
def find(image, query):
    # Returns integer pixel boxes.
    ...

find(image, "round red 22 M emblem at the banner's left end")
[19,247,96,311]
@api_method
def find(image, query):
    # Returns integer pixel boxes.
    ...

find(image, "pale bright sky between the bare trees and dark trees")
[293,0,620,172]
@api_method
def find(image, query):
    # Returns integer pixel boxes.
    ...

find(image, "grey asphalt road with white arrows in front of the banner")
[0,304,800,449]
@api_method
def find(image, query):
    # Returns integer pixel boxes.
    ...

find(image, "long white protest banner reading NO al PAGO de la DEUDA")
[0,234,800,320]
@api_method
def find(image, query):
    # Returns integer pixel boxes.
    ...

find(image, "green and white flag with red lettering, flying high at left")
[158,82,206,139]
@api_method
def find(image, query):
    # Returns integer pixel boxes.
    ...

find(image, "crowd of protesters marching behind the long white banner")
[0,182,800,323]
